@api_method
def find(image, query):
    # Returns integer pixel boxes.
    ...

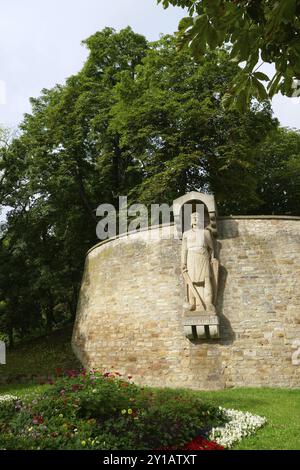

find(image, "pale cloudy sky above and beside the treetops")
[0,0,300,128]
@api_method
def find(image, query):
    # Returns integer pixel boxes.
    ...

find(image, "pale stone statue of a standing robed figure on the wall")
[181,212,218,314]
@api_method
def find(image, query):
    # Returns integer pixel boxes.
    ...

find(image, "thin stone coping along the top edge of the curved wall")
[87,215,300,255]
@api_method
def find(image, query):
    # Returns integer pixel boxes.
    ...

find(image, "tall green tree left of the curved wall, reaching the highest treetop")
[0,28,148,334]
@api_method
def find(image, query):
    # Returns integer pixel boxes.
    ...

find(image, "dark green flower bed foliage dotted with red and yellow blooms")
[0,371,224,450]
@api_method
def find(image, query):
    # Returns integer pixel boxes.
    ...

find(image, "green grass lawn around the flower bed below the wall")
[0,328,300,450]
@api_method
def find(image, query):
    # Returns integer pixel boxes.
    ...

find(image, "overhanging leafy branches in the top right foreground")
[158,0,300,109]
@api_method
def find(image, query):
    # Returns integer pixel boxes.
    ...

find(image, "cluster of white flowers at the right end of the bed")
[209,407,267,448]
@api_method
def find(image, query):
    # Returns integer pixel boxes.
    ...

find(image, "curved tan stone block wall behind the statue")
[73,217,300,389]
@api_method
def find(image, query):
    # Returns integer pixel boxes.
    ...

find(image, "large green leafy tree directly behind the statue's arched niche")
[110,36,278,214]
